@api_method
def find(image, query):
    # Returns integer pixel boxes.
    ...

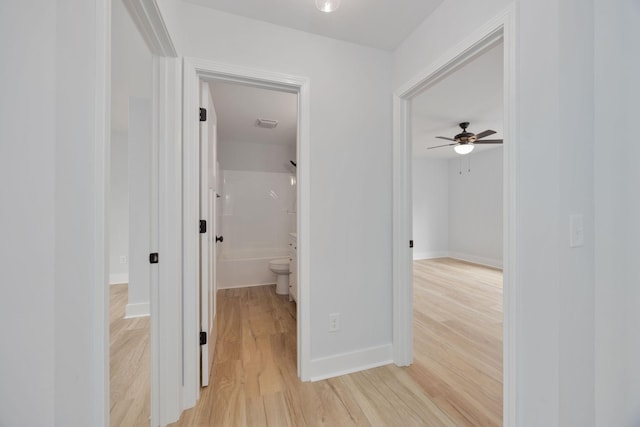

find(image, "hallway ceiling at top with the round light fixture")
[185,0,443,51]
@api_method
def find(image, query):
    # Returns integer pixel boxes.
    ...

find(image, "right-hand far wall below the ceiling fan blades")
[448,147,503,268]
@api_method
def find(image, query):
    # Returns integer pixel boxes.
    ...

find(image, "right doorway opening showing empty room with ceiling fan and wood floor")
[408,42,504,426]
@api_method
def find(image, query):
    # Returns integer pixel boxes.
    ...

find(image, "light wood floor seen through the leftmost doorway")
[109,284,151,427]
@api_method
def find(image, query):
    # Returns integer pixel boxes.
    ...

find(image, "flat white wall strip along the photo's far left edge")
[0,0,55,426]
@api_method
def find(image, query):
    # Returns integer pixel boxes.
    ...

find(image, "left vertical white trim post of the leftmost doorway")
[94,0,111,427]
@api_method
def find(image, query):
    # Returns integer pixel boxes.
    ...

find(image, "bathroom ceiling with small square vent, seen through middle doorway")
[209,80,298,147]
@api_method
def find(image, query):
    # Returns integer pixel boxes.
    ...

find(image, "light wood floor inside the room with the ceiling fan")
[408,258,502,426]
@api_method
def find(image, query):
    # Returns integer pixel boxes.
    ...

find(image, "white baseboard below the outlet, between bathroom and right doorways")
[311,344,393,381]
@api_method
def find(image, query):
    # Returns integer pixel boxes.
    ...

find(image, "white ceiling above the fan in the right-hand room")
[411,43,503,159]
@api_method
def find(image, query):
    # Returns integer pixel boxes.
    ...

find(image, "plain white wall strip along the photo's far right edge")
[594,0,640,427]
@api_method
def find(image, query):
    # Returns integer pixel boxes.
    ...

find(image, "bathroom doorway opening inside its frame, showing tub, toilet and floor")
[201,79,298,416]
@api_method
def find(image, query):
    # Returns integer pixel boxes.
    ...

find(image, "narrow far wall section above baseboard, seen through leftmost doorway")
[109,130,129,284]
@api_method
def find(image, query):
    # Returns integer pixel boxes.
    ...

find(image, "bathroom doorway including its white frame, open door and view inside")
[172,59,309,425]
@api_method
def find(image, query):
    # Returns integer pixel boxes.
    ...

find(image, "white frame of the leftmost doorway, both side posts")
[92,0,182,427]
